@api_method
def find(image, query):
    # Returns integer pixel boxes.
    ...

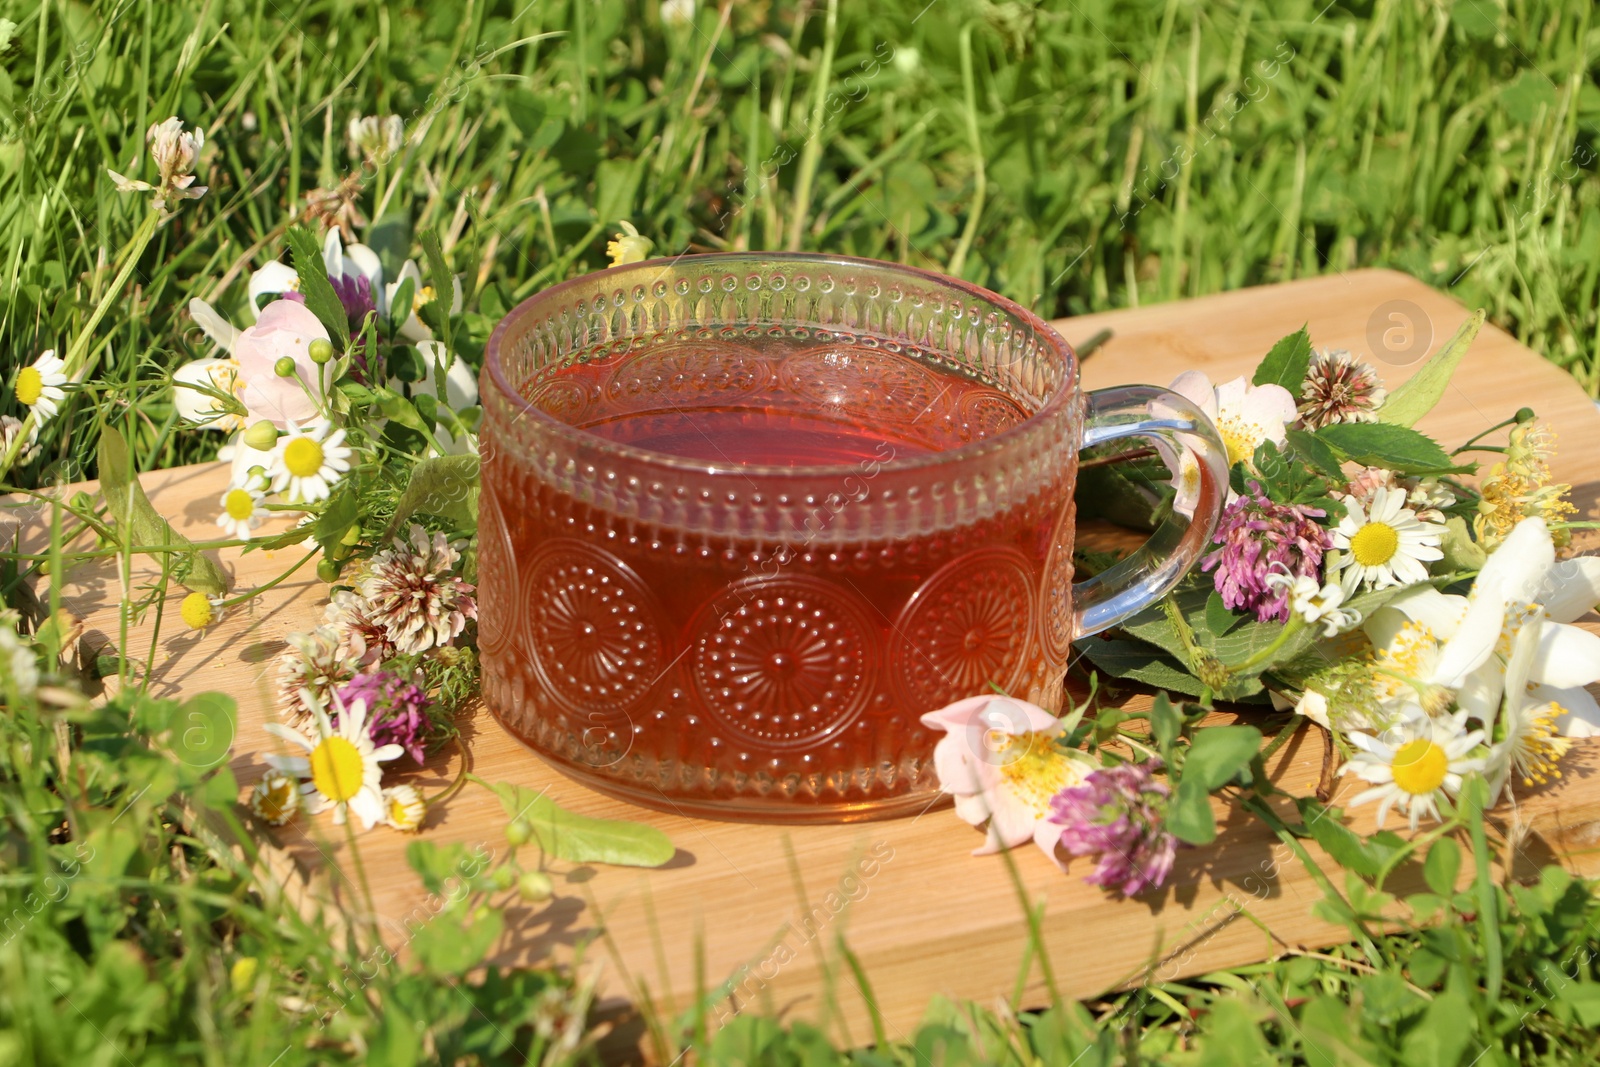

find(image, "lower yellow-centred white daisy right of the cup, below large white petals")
[1339,707,1483,830]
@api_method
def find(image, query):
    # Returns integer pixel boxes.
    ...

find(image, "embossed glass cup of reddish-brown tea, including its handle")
[478,253,1227,822]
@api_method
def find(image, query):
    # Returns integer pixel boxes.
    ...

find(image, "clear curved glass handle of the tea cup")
[1072,386,1227,640]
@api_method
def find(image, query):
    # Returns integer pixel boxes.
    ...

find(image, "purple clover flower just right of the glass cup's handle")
[1200,482,1333,622]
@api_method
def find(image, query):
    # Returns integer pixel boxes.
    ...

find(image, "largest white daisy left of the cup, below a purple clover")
[266,691,405,829]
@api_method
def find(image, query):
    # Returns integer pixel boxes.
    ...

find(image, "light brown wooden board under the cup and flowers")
[6,270,1600,1048]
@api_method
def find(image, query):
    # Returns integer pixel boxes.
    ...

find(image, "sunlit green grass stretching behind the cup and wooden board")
[0,0,1600,483]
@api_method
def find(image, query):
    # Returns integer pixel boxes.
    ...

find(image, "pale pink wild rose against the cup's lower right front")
[922,696,1093,869]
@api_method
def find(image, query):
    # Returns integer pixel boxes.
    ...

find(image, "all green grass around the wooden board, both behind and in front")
[0,0,1600,1067]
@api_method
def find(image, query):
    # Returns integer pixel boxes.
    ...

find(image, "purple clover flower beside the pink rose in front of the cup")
[1050,763,1178,896]
